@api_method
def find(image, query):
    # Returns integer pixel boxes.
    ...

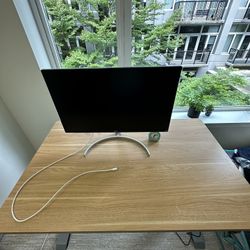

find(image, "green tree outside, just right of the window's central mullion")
[132,0,183,65]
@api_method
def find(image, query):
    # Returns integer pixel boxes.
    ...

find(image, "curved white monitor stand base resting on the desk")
[83,133,150,157]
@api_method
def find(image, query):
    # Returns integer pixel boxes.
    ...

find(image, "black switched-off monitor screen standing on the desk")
[42,66,181,132]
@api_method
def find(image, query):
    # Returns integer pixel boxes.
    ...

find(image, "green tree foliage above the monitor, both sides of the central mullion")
[43,0,182,68]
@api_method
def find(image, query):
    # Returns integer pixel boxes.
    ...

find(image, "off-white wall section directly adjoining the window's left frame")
[0,0,59,149]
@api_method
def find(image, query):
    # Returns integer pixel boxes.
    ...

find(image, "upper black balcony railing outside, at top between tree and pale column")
[174,0,227,21]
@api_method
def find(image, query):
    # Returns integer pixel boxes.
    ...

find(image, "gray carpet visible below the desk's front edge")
[0,232,233,250]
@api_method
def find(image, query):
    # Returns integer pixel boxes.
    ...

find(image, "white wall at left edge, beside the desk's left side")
[0,98,35,206]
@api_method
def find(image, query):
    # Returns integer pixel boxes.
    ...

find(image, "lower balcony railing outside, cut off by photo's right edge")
[227,48,250,64]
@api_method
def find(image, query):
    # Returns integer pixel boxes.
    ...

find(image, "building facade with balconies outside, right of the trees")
[161,0,250,75]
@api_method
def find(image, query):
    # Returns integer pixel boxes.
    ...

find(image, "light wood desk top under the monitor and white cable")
[0,119,250,233]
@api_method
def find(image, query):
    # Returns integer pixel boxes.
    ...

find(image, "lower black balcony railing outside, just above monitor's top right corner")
[167,50,211,65]
